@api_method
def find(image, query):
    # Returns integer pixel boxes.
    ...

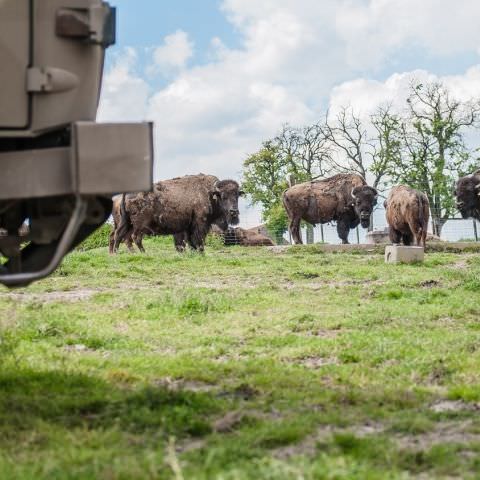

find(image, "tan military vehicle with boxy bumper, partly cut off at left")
[0,0,153,287]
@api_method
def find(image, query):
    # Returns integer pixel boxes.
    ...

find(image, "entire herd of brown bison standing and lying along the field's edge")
[109,170,480,253]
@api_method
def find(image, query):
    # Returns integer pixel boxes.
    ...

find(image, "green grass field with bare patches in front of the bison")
[0,239,480,480]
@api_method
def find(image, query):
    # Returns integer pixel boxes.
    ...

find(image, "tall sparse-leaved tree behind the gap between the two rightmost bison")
[385,83,480,236]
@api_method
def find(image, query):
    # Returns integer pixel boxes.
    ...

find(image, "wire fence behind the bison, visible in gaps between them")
[235,208,480,244]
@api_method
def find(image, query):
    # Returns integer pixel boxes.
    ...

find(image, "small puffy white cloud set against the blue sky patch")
[153,30,193,72]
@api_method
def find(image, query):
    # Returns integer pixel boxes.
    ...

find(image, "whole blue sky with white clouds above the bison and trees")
[99,0,480,225]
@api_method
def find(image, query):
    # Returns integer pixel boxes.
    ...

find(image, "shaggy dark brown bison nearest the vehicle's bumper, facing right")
[113,174,243,251]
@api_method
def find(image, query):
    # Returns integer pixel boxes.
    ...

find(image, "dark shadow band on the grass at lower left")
[0,370,218,444]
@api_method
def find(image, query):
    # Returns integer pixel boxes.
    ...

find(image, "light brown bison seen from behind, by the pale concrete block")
[384,185,430,248]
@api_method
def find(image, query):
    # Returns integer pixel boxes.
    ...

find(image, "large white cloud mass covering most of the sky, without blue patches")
[101,0,480,189]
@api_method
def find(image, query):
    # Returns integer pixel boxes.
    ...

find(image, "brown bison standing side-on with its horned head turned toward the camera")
[283,173,378,244]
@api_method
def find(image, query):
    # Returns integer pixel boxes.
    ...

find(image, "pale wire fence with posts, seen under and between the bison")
[236,204,480,244]
